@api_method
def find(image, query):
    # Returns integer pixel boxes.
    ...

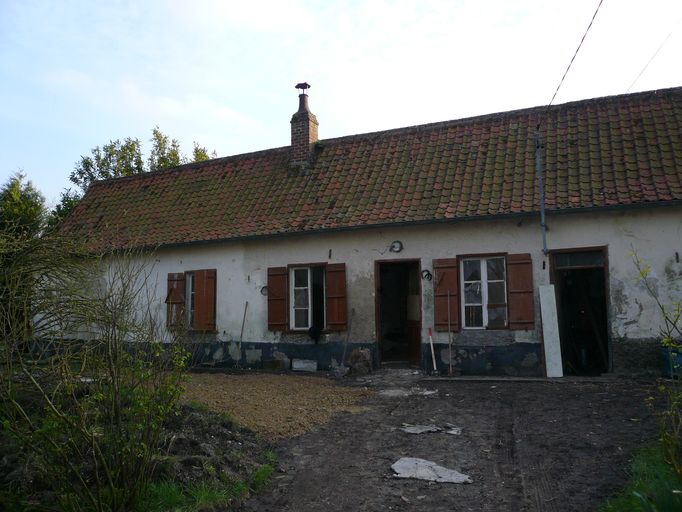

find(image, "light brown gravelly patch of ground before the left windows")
[184,373,373,440]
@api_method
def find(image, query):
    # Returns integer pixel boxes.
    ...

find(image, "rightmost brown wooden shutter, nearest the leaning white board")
[507,254,535,331]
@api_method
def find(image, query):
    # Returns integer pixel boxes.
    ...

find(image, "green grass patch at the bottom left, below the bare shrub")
[137,480,248,512]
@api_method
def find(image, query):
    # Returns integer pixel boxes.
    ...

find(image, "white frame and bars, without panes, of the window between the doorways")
[457,254,509,331]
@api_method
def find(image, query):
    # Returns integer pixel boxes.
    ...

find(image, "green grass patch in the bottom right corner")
[599,443,682,512]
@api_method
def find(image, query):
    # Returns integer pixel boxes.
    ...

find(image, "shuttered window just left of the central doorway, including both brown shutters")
[268,263,347,332]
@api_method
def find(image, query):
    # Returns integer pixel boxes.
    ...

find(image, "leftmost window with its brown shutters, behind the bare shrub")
[166,269,216,332]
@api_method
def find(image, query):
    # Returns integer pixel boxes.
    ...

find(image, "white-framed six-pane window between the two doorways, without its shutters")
[461,256,507,329]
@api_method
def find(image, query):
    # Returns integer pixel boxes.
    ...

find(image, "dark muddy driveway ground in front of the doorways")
[243,370,657,512]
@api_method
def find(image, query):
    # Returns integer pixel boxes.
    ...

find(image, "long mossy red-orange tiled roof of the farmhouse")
[62,87,682,252]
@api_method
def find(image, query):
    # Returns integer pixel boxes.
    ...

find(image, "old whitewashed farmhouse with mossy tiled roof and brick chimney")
[63,88,682,376]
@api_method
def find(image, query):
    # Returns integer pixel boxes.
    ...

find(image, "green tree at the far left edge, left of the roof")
[0,172,46,236]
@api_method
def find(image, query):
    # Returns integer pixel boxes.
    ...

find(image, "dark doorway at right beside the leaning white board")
[552,249,609,375]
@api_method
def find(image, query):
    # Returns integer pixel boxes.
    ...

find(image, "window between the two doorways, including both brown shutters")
[433,254,535,332]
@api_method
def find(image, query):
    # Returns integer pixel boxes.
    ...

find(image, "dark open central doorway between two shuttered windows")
[376,261,421,365]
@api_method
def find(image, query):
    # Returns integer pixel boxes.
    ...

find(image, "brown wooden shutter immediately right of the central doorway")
[433,258,459,332]
